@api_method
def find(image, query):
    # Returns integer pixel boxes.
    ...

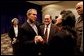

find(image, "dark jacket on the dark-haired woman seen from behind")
[49,29,75,55]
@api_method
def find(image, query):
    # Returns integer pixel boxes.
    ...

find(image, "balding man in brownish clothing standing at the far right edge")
[75,2,83,55]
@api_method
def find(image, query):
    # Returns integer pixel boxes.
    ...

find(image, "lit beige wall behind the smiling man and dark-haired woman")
[42,1,80,19]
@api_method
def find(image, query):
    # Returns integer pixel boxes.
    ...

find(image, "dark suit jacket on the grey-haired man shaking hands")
[21,22,40,55]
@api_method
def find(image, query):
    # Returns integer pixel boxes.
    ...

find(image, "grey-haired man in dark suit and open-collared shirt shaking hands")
[20,9,40,56]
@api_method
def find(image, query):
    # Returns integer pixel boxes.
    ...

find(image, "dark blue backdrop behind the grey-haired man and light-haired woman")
[0,1,42,34]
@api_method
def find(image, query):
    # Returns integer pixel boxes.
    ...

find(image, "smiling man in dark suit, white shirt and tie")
[40,15,56,42]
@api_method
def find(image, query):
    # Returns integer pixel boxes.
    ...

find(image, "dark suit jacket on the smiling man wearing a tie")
[40,24,58,56]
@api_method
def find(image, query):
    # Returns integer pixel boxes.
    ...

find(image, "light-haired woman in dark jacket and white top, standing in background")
[8,18,21,55]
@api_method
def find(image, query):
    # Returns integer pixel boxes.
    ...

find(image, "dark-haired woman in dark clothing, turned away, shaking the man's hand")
[50,10,76,55]
